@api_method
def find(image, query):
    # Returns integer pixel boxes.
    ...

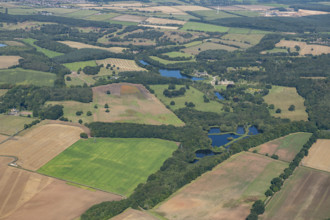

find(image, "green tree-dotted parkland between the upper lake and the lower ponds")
[150,85,222,113]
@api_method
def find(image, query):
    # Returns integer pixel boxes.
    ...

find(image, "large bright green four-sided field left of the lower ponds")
[38,138,177,196]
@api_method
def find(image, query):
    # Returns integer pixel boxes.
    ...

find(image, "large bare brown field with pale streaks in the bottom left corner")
[0,157,121,220]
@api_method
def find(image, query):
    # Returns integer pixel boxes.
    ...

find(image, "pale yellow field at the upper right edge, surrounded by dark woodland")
[275,40,330,55]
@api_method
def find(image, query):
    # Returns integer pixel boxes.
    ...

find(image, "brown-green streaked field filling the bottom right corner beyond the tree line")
[261,167,330,220]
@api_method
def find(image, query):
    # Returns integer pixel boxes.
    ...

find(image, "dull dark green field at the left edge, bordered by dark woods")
[0,68,56,86]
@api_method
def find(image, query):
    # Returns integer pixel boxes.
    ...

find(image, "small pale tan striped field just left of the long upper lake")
[96,58,145,72]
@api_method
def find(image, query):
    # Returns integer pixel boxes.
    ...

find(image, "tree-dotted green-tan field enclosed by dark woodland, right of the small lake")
[264,86,308,121]
